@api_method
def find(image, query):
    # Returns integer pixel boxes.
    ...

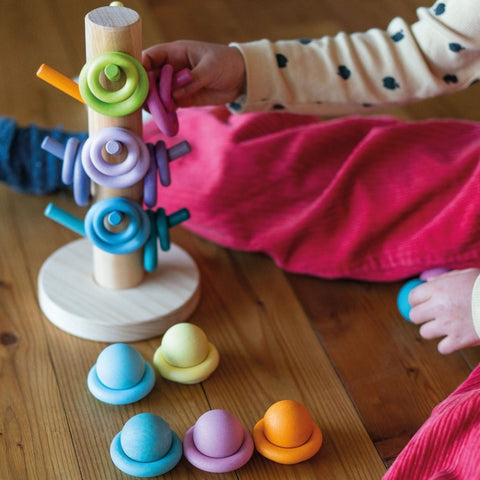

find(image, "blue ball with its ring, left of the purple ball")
[110,413,182,478]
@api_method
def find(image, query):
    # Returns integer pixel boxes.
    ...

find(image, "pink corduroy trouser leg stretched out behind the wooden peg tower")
[144,107,480,281]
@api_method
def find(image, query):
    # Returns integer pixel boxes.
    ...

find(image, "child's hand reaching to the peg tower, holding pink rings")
[142,40,245,107]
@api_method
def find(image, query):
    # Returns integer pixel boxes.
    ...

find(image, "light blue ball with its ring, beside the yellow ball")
[87,343,155,405]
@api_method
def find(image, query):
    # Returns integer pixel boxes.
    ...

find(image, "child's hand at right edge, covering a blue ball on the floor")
[408,268,480,354]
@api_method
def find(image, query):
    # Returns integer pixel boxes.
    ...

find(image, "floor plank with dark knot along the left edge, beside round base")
[0,185,81,480]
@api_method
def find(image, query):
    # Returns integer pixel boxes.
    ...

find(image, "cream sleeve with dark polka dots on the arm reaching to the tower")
[229,0,480,115]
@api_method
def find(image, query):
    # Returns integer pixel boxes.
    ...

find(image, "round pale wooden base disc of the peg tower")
[38,239,200,343]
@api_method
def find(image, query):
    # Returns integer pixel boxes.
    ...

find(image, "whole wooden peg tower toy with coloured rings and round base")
[37,2,200,342]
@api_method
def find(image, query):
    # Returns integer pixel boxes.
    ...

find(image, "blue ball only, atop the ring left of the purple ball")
[120,413,173,463]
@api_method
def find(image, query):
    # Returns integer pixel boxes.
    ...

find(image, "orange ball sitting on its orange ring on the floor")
[253,400,323,465]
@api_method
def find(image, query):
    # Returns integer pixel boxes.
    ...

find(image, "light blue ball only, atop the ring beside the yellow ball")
[96,343,145,390]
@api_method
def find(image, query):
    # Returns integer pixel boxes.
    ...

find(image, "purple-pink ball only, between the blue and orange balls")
[193,410,244,458]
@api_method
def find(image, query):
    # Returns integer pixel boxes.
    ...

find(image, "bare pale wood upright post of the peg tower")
[85,6,144,289]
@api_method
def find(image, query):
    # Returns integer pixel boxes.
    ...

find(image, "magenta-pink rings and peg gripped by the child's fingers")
[146,64,192,137]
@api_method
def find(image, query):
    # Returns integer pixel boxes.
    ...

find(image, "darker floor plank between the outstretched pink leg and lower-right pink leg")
[289,275,470,463]
